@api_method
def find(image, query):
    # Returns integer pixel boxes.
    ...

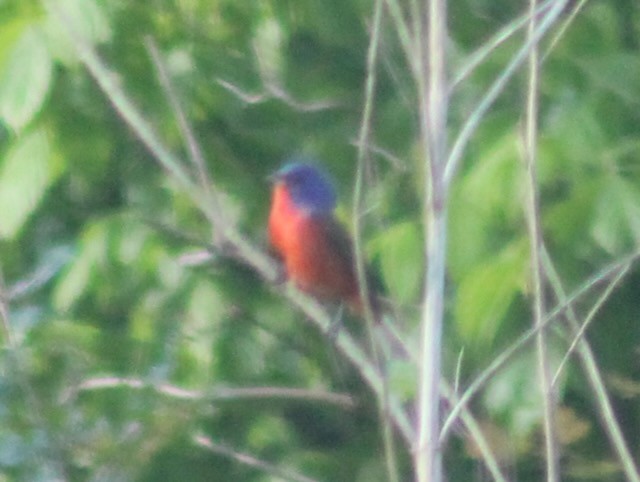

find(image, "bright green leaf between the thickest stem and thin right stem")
[455,240,529,347]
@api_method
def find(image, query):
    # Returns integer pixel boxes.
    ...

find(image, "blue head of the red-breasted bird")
[274,162,337,214]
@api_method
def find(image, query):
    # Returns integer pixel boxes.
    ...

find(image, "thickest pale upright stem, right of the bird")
[415,0,448,482]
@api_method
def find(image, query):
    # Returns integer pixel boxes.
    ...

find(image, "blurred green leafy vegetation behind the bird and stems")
[0,0,640,481]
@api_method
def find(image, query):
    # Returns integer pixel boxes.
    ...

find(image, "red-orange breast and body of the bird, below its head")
[269,182,360,306]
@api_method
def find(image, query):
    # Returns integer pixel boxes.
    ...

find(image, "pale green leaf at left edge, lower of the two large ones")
[0,129,58,238]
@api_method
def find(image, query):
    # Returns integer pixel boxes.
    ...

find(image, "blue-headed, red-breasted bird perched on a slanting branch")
[268,160,377,315]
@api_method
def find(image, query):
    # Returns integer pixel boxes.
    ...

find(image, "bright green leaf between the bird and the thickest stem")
[372,221,424,303]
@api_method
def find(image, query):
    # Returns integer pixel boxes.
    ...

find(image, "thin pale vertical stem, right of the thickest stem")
[525,0,559,482]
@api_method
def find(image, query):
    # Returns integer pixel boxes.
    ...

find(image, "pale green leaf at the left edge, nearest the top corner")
[0,27,52,131]
